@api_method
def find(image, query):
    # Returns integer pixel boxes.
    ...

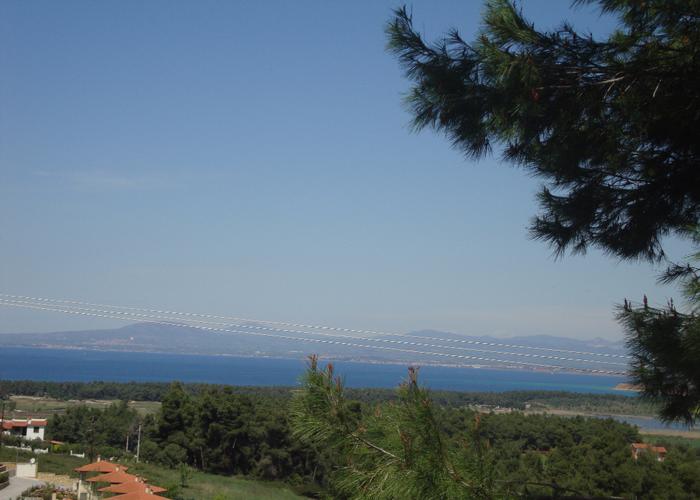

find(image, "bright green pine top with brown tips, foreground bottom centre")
[291,357,495,498]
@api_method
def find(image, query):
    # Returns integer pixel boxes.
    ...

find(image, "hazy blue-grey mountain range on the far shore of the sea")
[0,323,625,370]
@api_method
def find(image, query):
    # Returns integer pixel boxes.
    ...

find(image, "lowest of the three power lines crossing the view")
[2,302,626,375]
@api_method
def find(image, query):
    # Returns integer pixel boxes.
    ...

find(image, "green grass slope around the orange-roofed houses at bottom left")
[0,447,303,500]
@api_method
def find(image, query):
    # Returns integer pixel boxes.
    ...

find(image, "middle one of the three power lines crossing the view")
[0,298,627,366]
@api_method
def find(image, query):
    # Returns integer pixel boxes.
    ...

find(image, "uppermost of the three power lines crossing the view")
[0,293,632,359]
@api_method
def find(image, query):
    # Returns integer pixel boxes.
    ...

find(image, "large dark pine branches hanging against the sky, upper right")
[387,0,700,260]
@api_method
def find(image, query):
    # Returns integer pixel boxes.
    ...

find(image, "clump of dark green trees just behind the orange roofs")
[141,383,324,483]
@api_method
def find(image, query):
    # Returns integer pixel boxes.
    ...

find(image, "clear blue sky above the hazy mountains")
[0,0,684,338]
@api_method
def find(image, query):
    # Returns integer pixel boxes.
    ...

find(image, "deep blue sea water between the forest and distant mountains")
[0,346,682,429]
